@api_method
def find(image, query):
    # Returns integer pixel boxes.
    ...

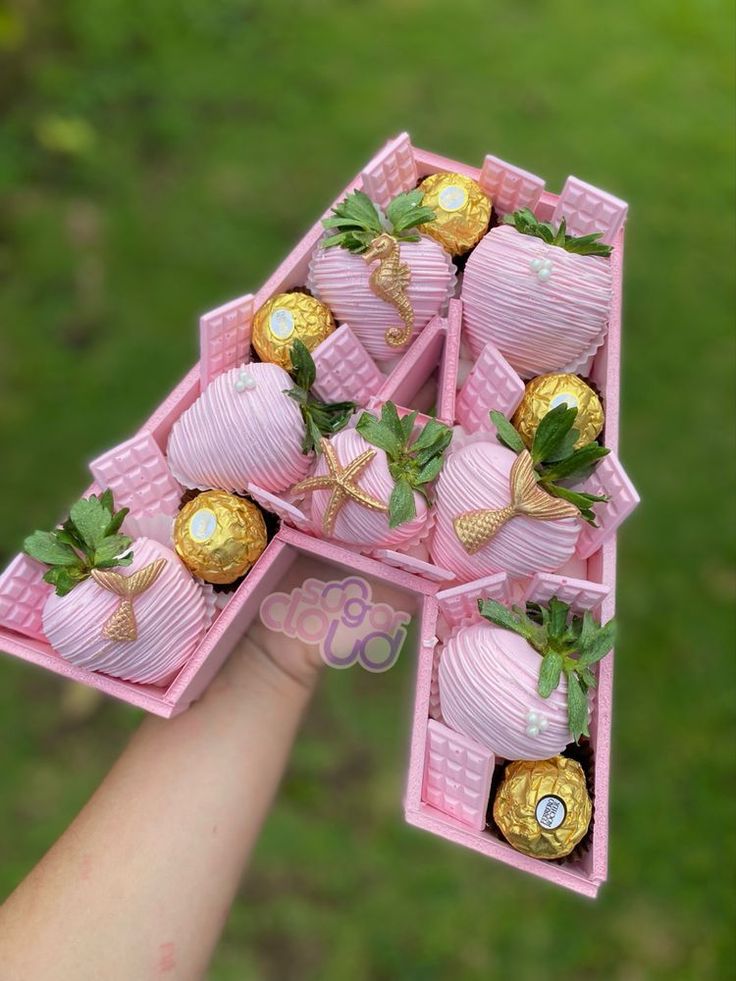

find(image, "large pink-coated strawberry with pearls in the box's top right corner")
[462,208,613,378]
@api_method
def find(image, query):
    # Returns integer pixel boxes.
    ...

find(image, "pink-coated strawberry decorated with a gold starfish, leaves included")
[292,402,452,550]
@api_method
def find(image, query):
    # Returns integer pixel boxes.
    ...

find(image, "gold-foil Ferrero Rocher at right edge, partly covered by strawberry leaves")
[511,374,603,449]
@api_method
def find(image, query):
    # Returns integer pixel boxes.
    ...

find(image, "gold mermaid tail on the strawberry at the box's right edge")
[453,450,580,555]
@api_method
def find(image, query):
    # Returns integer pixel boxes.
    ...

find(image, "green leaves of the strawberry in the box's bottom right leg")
[478,597,616,742]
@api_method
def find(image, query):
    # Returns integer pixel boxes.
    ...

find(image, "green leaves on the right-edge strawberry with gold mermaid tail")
[490,403,610,526]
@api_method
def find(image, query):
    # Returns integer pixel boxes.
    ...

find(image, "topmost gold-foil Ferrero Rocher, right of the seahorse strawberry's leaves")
[419,173,491,255]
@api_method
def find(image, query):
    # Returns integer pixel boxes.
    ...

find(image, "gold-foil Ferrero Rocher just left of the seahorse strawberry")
[251,293,335,371]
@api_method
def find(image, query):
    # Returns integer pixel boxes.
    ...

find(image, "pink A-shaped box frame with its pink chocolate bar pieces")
[0,134,638,897]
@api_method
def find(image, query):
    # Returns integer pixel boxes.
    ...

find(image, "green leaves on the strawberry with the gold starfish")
[356,402,452,528]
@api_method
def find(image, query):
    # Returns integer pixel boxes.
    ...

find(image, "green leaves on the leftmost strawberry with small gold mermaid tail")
[23,490,133,596]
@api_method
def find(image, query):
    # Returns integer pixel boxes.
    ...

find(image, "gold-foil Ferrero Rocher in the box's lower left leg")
[174,490,266,584]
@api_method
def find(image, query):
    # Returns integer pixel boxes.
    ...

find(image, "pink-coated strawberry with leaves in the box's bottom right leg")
[438,598,614,760]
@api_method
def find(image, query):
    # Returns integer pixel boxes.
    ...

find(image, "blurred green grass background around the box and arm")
[0,0,736,981]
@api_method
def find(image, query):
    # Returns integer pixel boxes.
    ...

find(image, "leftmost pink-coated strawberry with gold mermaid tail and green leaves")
[24,491,211,685]
